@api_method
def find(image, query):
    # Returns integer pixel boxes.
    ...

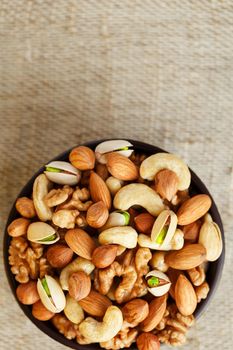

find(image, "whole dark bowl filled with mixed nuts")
[4,139,225,350]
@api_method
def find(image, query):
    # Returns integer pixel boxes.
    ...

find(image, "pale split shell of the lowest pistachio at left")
[37,275,66,313]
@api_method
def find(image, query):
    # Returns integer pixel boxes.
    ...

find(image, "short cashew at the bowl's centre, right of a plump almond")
[99,226,138,249]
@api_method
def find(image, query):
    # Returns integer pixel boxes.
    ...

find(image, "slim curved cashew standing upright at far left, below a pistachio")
[32,174,53,221]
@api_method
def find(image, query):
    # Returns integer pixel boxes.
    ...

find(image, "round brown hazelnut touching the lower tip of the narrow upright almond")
[86,201,109,228]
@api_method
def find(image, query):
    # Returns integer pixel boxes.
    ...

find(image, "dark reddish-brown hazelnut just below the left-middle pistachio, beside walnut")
[47,244,74,269]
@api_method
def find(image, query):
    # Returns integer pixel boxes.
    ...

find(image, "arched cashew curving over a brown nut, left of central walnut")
[60,256,95,290]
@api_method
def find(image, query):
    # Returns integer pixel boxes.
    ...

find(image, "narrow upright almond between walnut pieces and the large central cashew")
[89,171,112,209]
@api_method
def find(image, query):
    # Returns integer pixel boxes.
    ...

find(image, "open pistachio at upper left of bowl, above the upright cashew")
[44,161,81,186]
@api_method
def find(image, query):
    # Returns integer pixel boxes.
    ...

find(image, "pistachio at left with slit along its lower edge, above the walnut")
[27,221,60,244]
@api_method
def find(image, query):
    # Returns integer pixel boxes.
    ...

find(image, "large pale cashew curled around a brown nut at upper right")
[140,153,191,191]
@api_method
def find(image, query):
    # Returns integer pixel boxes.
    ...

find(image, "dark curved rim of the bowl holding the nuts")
[3,138,225,350]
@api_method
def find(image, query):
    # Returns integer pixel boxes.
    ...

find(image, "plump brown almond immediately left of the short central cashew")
[65,228,96,260]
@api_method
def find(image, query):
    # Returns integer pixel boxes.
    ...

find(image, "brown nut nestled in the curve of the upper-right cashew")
[155,169,179,201]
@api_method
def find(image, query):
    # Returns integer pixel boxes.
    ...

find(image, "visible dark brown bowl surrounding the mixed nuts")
[3,140,225,350]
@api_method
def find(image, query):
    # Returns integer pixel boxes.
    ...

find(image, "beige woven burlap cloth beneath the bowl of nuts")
[0,0,233,350]
